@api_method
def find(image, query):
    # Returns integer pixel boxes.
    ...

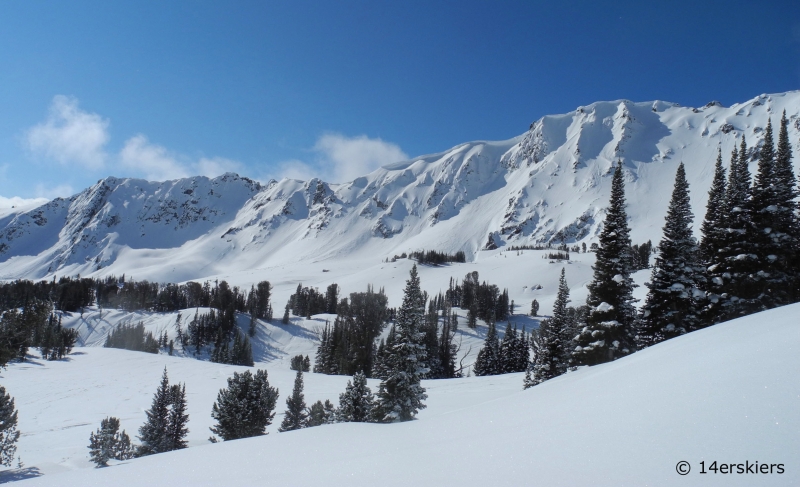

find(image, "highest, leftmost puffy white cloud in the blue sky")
[25,95,109,169]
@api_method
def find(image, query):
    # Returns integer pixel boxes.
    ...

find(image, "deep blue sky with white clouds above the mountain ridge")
[0,0,800,205]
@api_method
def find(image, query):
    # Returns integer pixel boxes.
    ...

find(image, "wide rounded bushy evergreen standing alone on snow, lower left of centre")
[210,370,278,441]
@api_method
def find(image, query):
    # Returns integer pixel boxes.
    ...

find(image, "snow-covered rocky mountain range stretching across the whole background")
[0,91,800,282]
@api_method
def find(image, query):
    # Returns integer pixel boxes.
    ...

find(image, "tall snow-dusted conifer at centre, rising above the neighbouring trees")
[376,264,428,422]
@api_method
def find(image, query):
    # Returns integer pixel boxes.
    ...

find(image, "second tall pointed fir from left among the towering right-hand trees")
[636,164,704,348]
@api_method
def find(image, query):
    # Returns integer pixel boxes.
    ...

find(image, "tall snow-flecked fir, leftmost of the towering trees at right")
[573,162,636,365]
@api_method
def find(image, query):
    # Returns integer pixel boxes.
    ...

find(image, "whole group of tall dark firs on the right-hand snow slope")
[525,114,800,387]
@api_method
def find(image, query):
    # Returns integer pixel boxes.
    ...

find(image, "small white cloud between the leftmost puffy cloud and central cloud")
[119,134,189,181]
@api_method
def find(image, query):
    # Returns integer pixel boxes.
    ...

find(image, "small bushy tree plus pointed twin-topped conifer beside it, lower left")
[89,367,189,467]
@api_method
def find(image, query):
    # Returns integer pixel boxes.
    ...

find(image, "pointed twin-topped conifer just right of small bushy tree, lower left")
[136,367,189,456]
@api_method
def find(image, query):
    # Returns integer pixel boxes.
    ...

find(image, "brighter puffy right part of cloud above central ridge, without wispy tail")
[314,134,408,183]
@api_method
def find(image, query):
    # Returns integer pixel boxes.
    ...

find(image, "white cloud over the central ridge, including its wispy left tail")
[278,133,409,183]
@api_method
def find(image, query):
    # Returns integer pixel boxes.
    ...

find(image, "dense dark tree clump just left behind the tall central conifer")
[314,287,389,375]
